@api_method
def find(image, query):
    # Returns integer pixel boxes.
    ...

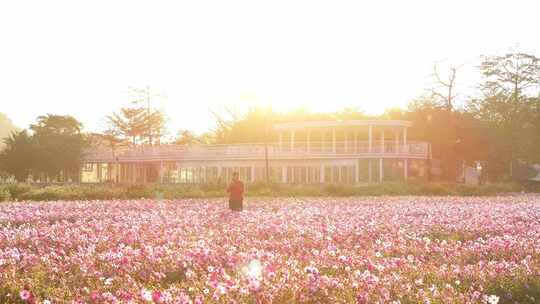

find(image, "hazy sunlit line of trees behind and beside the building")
[0,52,540,182]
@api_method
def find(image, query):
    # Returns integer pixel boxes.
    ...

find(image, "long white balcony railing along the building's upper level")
[85,141,429,161]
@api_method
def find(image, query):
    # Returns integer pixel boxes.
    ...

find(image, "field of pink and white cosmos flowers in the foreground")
[0,195,540,303]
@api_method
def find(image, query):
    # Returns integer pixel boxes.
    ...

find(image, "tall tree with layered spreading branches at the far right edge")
[467,52,540,177]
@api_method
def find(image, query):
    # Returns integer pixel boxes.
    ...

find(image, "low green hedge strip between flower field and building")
[0,183,540,201]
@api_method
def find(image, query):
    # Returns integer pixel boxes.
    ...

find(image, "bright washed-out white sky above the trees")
[0,0,540,133]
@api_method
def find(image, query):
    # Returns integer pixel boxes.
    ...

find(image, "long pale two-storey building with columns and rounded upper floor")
[81,120,431,184]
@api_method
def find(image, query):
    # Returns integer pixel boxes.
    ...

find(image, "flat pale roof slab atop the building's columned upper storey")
[274,120,412,130]
